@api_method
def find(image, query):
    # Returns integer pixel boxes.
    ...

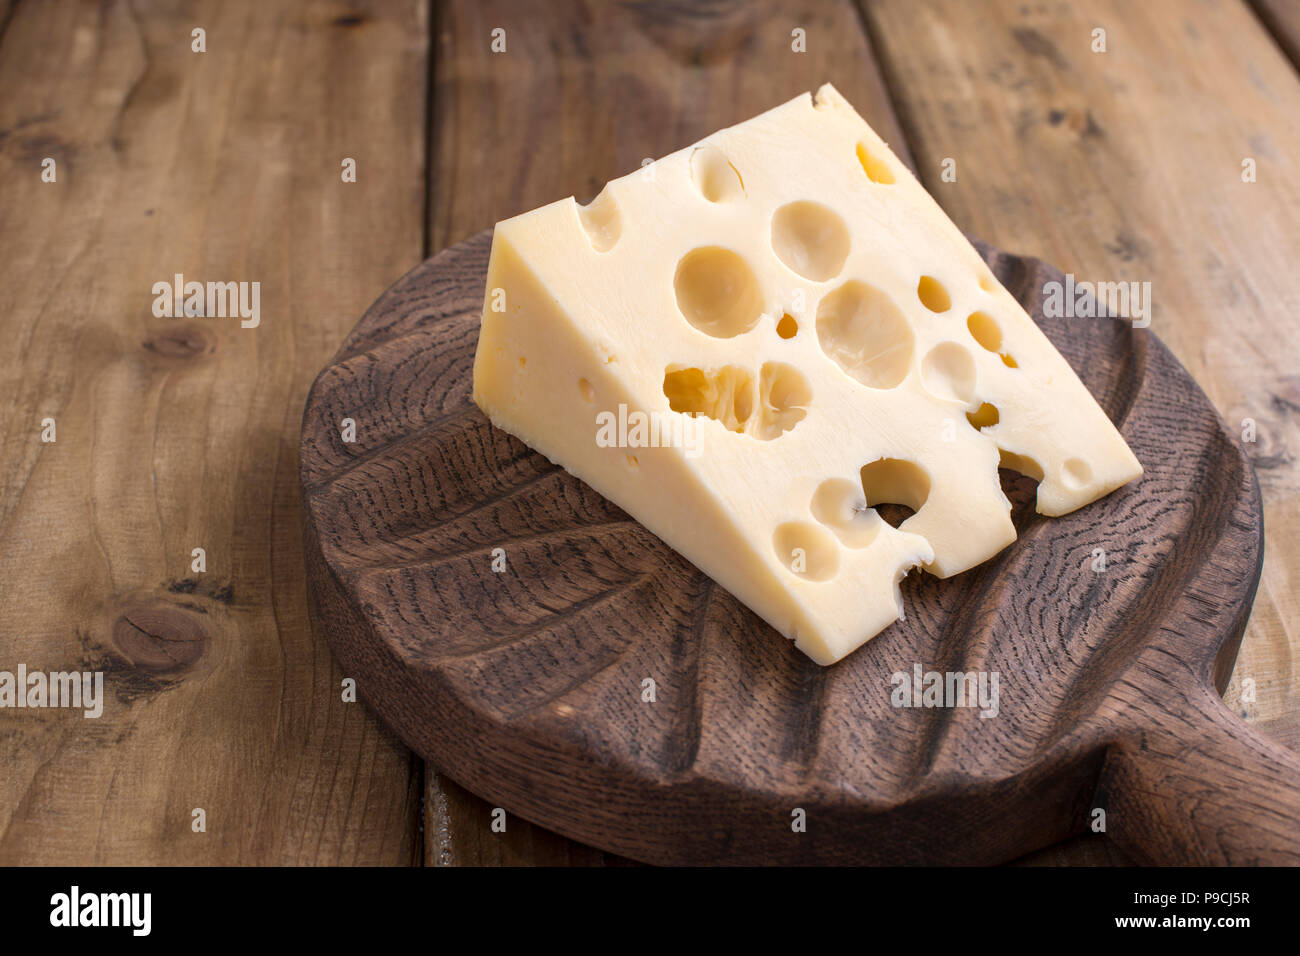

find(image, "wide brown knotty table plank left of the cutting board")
[0,0,428,865]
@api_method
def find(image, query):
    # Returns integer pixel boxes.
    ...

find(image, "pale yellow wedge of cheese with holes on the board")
[473,86,1141,665]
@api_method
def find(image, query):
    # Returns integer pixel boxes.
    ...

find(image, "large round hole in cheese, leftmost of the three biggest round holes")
[672,246,763,338]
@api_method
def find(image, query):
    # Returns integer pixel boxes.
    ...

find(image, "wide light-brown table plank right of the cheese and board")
[863,0,1300,822]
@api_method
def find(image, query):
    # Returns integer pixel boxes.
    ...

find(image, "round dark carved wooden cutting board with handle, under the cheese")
[300,230,1300,864]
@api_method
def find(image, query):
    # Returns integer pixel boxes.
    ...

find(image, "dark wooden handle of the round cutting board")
[1099,687,1300,866]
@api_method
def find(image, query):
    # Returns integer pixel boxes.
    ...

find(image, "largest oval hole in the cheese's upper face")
[816,280,914,389]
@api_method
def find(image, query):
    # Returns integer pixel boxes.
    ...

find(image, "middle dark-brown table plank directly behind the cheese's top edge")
[425,0,907,864]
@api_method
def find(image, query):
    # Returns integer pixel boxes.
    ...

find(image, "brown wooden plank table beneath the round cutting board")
[0,0,1300,865]
